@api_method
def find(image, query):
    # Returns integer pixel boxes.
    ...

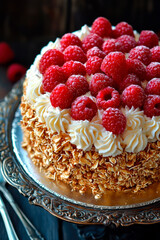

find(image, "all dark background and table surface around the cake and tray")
[0,0,160,240]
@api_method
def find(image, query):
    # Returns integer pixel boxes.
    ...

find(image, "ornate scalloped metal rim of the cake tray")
[0,81,160,226]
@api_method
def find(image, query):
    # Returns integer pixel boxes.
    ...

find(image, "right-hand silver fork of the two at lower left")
[0,162,44,240]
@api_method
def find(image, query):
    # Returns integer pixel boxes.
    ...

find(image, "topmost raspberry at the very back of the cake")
[91,17,112,38]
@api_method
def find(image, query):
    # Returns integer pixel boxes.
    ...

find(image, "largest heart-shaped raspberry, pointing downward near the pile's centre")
[101,52,126,83]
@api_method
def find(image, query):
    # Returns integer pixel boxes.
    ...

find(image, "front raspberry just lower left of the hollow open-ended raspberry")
[71,96,97,121]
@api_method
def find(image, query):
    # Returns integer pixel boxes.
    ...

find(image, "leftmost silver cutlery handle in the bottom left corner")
[0,197,19,240]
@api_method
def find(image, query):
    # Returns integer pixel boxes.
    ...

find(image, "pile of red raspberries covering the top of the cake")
[39,17,160,135]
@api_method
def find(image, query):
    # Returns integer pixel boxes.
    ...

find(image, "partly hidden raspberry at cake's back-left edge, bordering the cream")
[60,33,82,51]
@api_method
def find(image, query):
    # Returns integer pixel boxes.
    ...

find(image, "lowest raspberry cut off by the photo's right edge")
[143,95,160,117]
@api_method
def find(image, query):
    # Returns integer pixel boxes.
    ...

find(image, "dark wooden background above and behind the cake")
[0,0,160,67]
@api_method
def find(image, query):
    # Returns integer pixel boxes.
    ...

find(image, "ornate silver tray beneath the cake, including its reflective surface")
[0,81,160,226]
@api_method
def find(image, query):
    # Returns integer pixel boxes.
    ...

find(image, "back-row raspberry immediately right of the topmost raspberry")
[114,22,134,38]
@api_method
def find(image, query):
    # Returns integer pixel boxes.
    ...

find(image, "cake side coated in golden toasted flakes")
[21,79,160,198]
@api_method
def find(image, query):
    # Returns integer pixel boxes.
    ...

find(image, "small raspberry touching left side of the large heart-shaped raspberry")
[86,56,103,75]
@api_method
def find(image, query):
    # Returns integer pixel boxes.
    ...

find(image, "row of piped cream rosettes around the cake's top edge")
[26,66,160,157]
